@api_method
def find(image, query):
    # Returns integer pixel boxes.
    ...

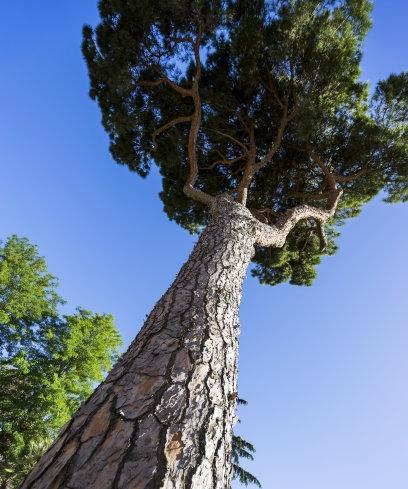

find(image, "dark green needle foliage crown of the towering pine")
[83,0,408,285]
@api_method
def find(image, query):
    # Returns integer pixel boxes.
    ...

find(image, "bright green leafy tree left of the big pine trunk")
[0,236,121,488]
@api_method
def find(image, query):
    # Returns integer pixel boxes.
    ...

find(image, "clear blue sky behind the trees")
[0,0,408,489]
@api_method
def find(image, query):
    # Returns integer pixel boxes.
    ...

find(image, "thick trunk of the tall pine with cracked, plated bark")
[21,199,256,489]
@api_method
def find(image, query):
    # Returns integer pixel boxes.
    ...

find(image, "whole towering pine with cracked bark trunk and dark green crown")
[23,0,408,489]
